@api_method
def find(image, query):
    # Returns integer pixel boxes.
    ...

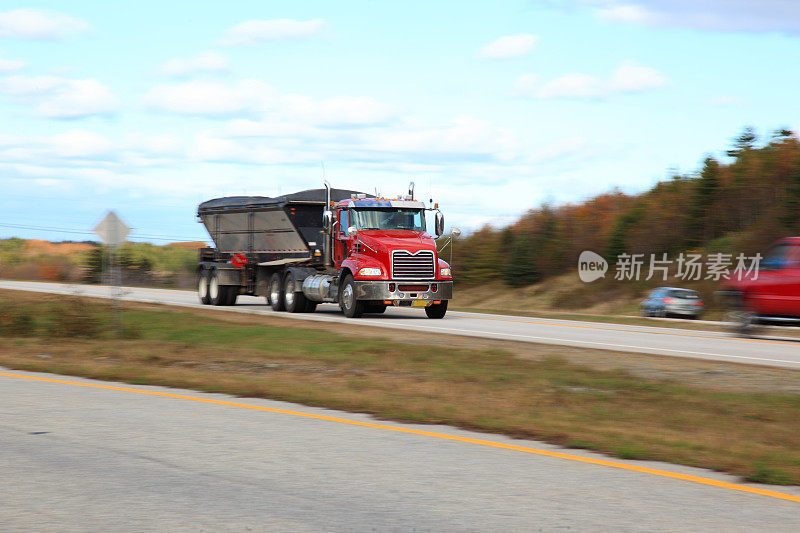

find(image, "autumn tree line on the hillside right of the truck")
[453,127,800,287]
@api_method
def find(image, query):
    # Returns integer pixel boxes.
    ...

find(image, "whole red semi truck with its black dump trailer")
[197,183,453,318]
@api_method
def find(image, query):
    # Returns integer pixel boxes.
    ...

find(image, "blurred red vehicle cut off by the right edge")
[721,237,800,333]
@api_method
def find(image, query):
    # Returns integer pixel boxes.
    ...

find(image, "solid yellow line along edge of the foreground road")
[0,372,800,503]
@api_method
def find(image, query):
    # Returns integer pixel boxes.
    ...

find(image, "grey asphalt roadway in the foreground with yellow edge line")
[0,368,800,532]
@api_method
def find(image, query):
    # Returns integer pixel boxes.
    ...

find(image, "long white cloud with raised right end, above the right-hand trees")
[513,61,668,99]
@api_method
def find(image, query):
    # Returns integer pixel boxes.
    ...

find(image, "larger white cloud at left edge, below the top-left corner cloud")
[0,76,119,119]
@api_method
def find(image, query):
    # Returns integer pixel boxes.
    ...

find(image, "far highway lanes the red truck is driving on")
[0,280,800,368]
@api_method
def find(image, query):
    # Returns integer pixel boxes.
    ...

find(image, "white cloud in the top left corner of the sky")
[0,9,89,40]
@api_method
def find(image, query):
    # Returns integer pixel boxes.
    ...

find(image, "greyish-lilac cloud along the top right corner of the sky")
[584,0,800,34]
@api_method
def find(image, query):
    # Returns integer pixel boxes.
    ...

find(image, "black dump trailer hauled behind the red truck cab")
[197,189,362,311]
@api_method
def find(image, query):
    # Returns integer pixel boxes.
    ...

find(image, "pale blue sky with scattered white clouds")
[0,0,800,244]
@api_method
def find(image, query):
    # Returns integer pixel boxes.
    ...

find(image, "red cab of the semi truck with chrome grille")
[329,195,453,318]
